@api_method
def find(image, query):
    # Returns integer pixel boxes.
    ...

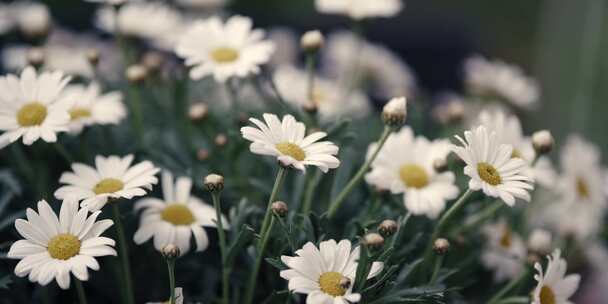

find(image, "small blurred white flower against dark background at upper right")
[464,55,540,109]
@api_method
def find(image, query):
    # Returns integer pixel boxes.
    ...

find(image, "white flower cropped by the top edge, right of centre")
[315,0,403,20]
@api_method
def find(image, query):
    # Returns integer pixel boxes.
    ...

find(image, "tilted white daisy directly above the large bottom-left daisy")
[55,155,160,211]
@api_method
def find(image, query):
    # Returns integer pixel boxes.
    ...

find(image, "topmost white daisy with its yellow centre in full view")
[175,15,274,82]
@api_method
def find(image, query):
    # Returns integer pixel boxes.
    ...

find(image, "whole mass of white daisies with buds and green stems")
[0,0,608,304]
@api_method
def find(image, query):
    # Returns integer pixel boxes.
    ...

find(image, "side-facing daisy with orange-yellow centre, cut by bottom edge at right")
[532,249,581,304]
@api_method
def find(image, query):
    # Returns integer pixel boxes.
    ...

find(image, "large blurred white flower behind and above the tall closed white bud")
[323,32,416,99]
